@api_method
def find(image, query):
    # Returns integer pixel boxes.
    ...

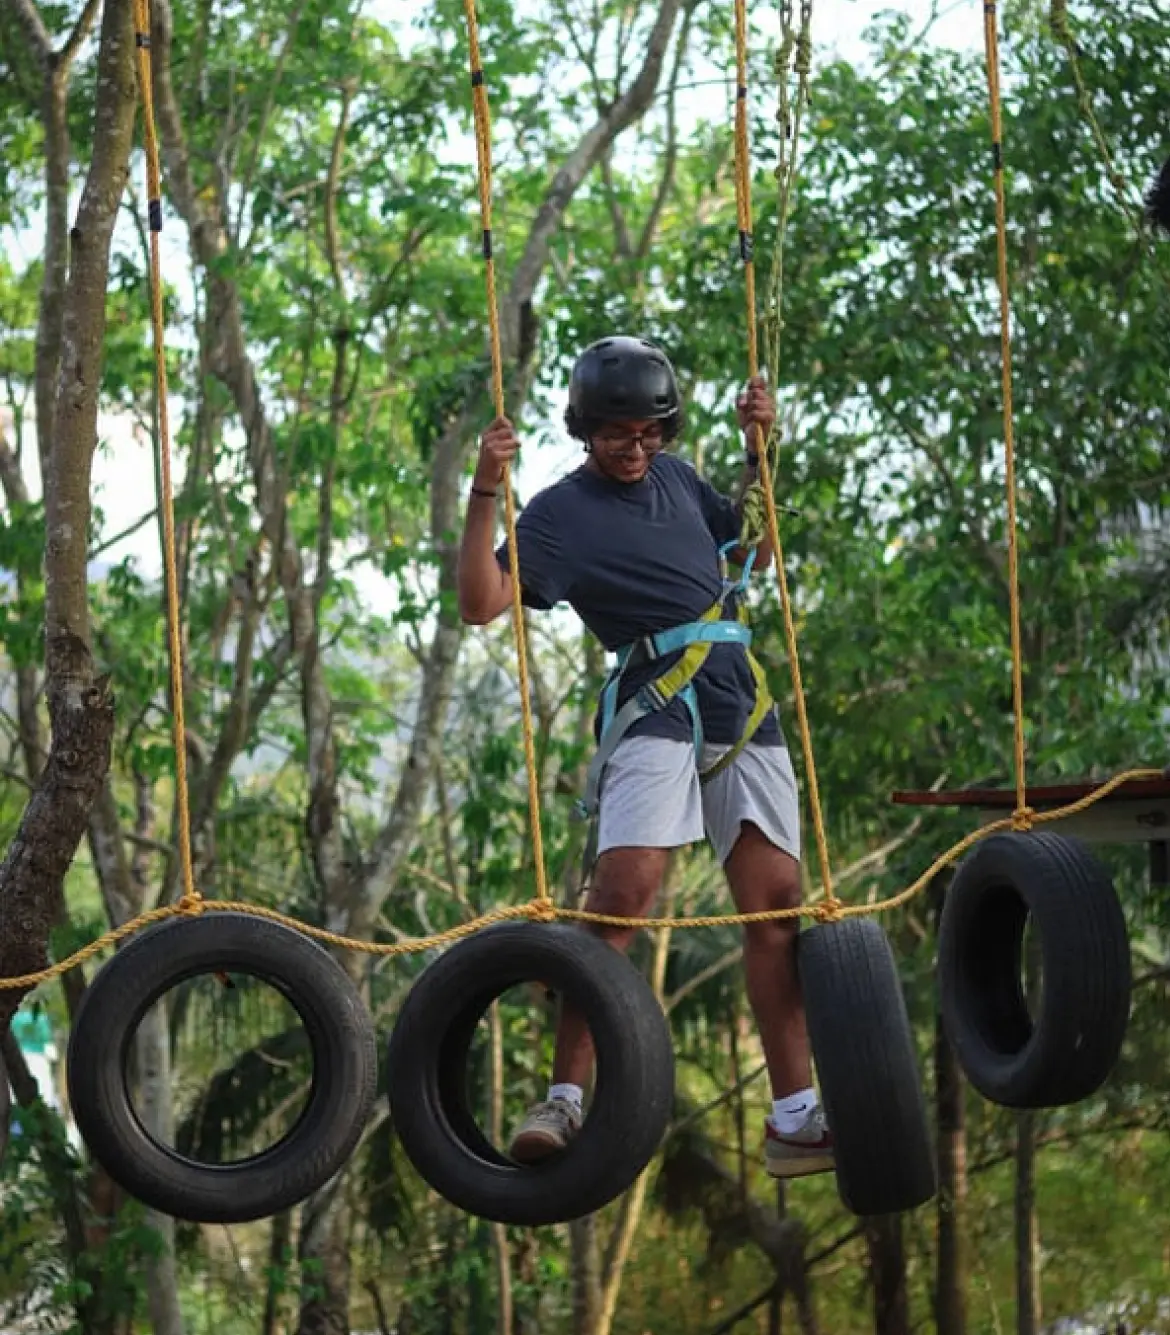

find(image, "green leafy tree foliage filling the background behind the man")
[0,0,1170,1335]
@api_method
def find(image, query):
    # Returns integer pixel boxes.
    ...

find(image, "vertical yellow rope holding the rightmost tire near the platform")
[983,0,1032,829]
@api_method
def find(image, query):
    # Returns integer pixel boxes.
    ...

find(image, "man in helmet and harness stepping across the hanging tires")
[458,336,833,1177]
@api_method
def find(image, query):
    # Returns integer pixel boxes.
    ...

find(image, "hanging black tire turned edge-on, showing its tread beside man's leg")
[796,917,938,1216]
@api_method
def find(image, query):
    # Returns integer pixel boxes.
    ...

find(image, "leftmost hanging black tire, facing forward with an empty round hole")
[68,912,378,1224]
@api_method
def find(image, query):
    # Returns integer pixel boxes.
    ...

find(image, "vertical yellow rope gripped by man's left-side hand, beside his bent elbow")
[463,0,553,912]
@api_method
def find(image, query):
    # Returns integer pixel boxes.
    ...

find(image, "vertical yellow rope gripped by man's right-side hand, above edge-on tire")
[735,0,840,913]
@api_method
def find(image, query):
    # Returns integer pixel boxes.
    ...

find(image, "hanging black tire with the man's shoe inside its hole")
[386,922,674,1227]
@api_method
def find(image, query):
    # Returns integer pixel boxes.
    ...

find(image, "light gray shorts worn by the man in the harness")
[597,737,800,865]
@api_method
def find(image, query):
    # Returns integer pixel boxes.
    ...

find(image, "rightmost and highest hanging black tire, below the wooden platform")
[938,830,1131,1108]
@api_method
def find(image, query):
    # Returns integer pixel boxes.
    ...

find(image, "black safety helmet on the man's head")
[565,334,683,441]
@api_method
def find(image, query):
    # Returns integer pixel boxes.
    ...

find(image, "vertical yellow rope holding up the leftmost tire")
[134,0,203,912]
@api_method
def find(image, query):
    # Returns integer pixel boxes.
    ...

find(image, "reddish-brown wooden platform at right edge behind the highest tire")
[892,777,1170,885]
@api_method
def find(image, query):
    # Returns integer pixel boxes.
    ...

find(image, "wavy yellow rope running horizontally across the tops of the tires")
[0,768,1165,991]
